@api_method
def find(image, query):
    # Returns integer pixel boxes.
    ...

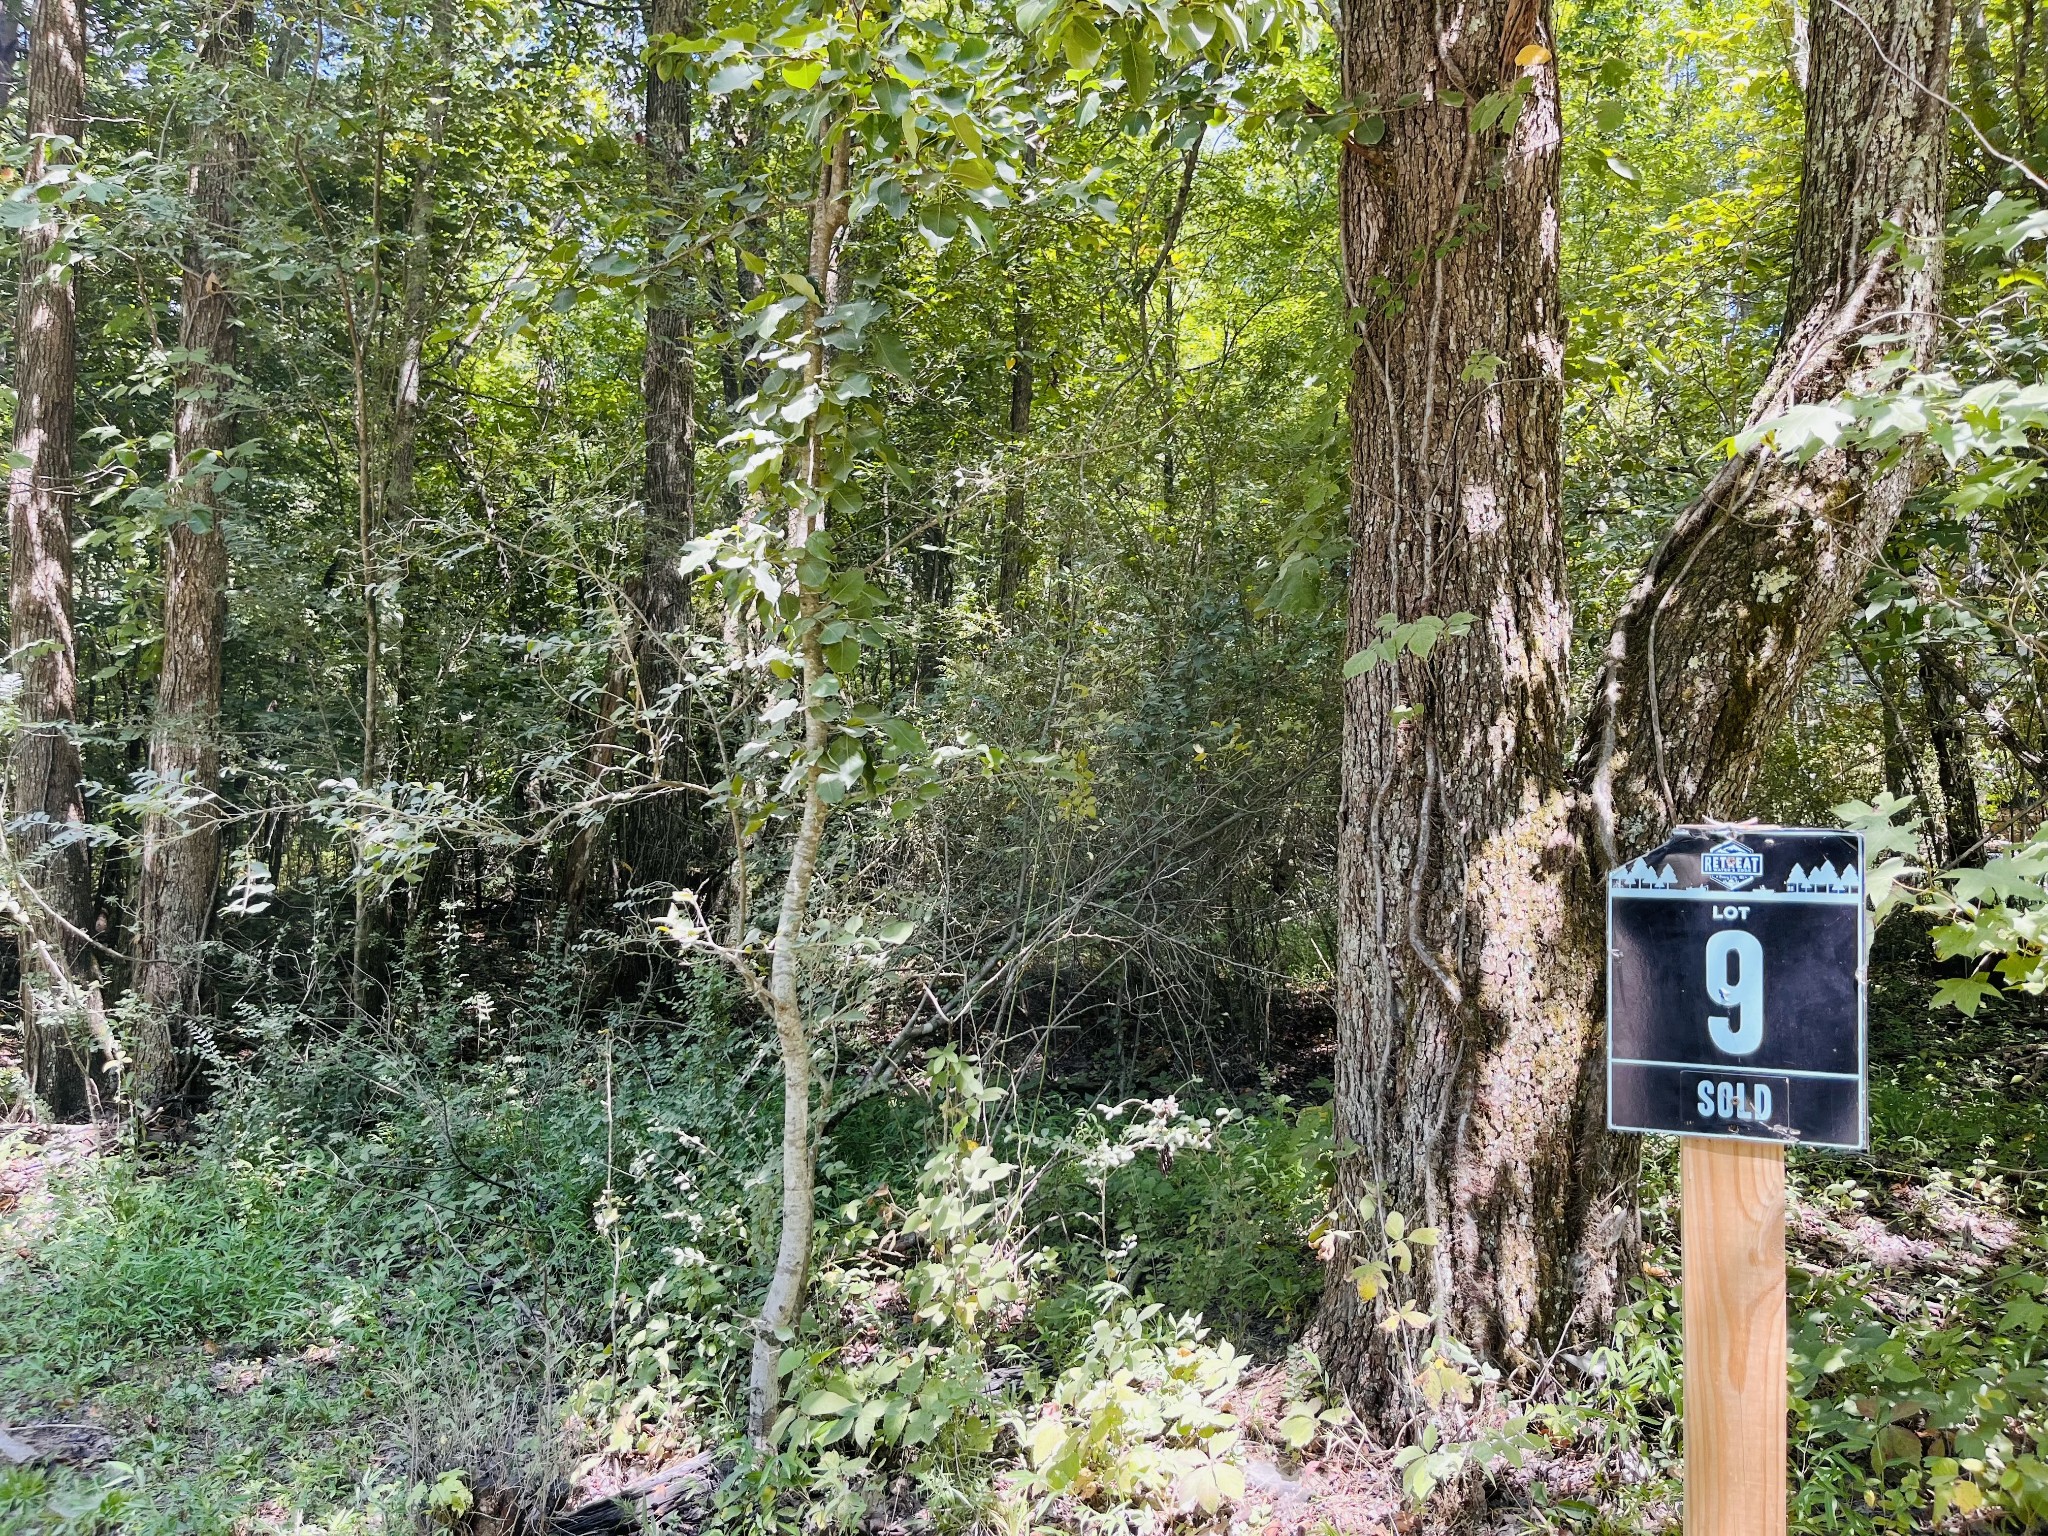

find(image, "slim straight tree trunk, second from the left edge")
[133,0,252,1120]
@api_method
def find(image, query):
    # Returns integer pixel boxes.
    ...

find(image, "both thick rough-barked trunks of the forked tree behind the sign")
[1321,0,1950,1423]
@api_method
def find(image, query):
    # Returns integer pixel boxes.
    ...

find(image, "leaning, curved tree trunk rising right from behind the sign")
[1552,0,1950,1323]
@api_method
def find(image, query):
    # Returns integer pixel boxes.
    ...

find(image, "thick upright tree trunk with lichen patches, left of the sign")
[1321,0,1575,1425]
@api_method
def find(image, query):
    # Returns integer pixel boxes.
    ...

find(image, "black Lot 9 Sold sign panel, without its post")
[1608,827,1870,1149]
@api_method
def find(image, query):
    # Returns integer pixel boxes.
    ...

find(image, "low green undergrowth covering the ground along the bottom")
[0,934,2048,1536]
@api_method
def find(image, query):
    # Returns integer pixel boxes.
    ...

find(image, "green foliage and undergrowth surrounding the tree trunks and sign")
[0,0,2048,1536]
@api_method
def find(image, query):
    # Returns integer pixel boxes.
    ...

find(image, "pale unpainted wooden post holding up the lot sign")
[1679,1137,1786,1536]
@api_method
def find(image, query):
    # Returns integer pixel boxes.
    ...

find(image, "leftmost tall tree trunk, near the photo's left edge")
[8,0,98,1118]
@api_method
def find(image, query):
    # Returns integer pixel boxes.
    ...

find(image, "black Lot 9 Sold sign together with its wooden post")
[1608,827,1868,1536]
